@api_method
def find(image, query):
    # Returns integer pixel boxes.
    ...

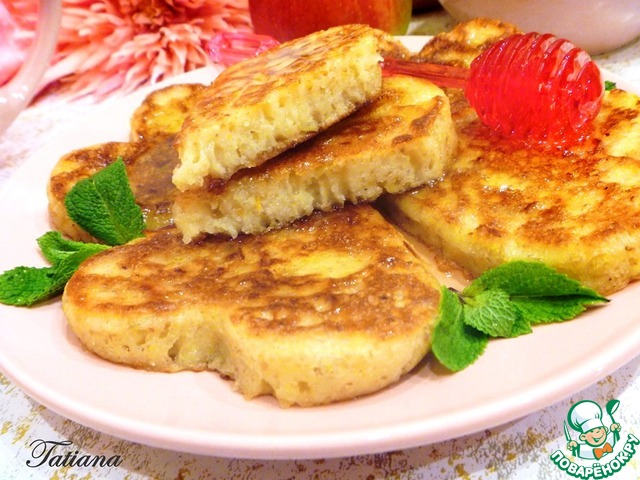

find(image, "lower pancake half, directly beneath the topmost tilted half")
[173,75,456,241]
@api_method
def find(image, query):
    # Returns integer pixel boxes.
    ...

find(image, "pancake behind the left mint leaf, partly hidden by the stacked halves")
[47,84,204,241]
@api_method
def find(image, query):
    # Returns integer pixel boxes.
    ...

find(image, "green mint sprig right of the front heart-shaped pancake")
[431,261,608,371]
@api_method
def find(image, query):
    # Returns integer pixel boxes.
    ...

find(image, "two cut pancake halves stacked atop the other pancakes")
[173,25,456,242]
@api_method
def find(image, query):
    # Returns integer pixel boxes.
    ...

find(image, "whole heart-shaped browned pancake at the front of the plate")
[62,205,439,406]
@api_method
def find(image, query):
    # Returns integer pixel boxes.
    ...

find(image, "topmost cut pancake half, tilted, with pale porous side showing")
[173,25,382,191]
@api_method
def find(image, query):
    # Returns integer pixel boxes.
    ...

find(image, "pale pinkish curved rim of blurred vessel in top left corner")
[0,0,62,134]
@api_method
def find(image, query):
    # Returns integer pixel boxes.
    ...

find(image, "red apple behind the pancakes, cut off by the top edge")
[249,0,412,42]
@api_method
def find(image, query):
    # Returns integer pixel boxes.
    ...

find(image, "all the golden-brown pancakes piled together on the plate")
[49,20,640,406]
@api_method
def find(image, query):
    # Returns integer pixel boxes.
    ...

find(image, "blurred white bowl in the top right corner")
[440,0,640,55]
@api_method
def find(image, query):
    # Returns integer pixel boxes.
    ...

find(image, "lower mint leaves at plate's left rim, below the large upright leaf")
[0,238,109,306]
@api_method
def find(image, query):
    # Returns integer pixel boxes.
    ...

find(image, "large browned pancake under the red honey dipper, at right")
[384,18,640,295]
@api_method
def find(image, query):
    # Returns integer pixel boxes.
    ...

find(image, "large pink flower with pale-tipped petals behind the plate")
[3,0,251,99]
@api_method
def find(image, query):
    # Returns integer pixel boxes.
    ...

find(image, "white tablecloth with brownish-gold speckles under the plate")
[0,12,640,480]
